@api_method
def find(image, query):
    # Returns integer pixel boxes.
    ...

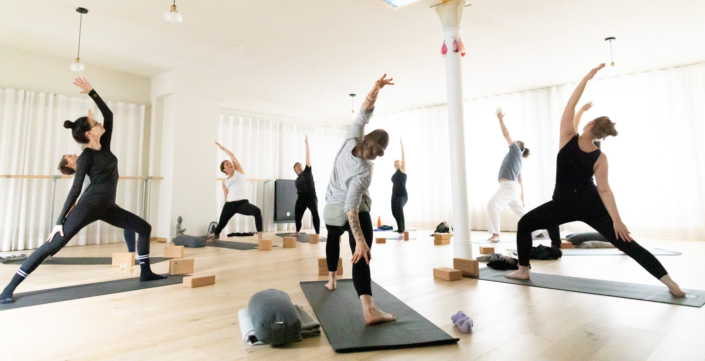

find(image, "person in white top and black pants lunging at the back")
[207,142,262,242]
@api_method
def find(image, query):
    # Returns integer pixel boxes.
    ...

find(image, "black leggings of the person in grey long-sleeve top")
[326,212,373,296]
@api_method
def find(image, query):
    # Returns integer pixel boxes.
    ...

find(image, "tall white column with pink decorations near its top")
[436,0,472,259]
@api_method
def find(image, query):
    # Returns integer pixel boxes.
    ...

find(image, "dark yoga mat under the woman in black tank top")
[480,267,705,307]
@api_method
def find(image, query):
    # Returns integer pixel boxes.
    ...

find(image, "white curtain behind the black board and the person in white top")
[213,114,346,235]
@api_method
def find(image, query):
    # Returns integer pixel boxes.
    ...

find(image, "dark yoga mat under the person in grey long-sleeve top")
[301,279,458,353]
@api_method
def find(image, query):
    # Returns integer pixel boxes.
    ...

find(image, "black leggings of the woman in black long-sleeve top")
[20,199,152,274]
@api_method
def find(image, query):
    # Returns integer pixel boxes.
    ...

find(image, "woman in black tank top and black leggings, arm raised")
[505,64,685,297]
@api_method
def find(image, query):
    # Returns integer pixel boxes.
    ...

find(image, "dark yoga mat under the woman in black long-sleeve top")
[0,275,185,311]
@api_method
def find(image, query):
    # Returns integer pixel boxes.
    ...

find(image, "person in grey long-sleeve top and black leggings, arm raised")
[323,74,396,325]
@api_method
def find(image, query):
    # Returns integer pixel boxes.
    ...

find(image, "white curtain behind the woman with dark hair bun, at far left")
[0,89,145,251]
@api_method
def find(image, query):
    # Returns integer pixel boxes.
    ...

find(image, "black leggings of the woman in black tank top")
[517,188,668,279]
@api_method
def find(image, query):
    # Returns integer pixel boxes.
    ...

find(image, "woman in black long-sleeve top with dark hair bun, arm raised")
[0,78,166,303]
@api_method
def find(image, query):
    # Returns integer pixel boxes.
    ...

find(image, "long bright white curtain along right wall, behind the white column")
[371,63,705,239]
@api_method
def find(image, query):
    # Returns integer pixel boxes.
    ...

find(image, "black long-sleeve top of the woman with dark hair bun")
[56,90,120,225]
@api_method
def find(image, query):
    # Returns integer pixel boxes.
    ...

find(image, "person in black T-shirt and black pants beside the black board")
[294,136,321,234]
